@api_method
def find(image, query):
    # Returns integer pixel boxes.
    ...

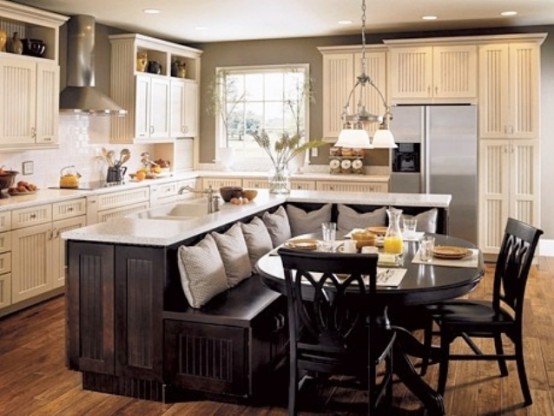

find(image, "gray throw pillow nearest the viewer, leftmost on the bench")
[177,235,229,308]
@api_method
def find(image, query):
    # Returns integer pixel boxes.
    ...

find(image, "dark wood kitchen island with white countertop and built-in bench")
[62,191,450,401]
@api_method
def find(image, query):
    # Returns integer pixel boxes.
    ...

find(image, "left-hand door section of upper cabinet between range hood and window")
[134,75,171,143]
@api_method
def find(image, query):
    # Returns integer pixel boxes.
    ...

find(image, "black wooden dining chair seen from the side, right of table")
[427,218,543,405]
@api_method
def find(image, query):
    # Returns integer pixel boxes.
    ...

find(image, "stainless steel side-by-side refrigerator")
[391,105,478,243]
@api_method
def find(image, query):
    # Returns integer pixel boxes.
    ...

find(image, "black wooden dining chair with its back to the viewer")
[279,248,395,415]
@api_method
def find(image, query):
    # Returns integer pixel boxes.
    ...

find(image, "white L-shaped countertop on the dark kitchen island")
[62,190,451,246]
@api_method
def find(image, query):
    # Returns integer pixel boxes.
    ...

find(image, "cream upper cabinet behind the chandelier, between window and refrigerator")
[318,46,387,140]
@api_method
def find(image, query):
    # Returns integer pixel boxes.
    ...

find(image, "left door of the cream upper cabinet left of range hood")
[0,57,37,145]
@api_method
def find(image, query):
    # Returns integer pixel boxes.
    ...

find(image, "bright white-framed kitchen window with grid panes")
[211,64,312,170]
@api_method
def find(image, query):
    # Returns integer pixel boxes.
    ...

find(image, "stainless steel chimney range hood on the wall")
[60,15,127,116]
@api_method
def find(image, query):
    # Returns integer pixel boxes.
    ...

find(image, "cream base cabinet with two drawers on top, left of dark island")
[11,198,86,304]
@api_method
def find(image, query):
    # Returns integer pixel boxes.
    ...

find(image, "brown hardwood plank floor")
[0,258,554,416]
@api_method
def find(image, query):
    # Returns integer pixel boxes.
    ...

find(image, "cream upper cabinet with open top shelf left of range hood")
[0,0,68,150]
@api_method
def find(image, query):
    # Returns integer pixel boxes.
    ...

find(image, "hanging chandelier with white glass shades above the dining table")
[335,0,397,149]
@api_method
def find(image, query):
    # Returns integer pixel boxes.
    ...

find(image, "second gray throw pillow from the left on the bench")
[211,223,252,287]
